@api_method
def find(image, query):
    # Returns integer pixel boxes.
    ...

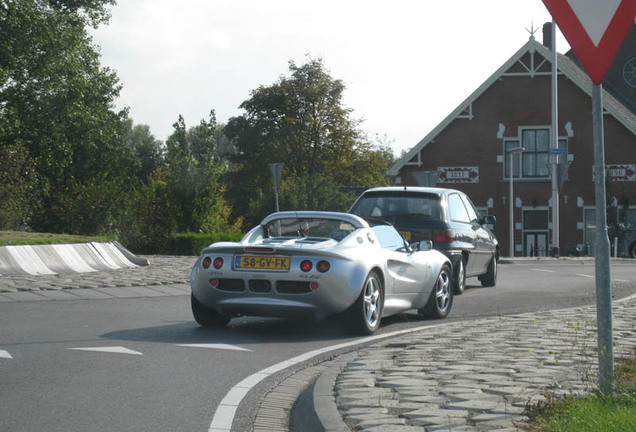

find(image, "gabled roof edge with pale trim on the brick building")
[387,36,636,176]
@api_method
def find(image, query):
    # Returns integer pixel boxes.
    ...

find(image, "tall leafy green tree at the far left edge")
[0,0,132,234]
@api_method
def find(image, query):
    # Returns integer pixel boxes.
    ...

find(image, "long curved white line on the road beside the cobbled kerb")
[208,326,435,432]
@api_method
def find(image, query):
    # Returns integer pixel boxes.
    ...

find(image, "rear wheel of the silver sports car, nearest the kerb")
[350,271,384,335]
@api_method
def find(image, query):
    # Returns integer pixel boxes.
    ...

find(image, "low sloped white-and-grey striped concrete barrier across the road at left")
[0,242,148,276]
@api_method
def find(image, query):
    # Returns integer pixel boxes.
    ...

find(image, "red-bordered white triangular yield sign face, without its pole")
[543,0,636,85]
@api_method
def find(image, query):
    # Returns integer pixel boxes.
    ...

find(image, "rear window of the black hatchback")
[349,191,441,221]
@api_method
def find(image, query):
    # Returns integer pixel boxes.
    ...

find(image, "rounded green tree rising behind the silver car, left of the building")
[225,58,393,223]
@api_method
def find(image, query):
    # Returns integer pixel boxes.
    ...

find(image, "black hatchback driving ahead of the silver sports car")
[349,186,499,294]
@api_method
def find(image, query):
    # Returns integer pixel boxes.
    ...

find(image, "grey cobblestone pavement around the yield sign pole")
[326,296,636,432]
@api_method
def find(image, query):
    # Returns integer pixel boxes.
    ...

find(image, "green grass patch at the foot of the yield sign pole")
[529,349,636,432]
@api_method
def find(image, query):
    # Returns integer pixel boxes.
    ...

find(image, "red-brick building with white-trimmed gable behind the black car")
[388,24,636,256]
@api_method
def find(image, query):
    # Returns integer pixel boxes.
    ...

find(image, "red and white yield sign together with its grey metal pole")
[543,0,636,395]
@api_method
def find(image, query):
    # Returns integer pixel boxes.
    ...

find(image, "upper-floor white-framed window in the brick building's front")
[504,128,567,179]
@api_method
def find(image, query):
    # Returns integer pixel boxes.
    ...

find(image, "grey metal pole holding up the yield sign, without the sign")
[592,84,614,395]
